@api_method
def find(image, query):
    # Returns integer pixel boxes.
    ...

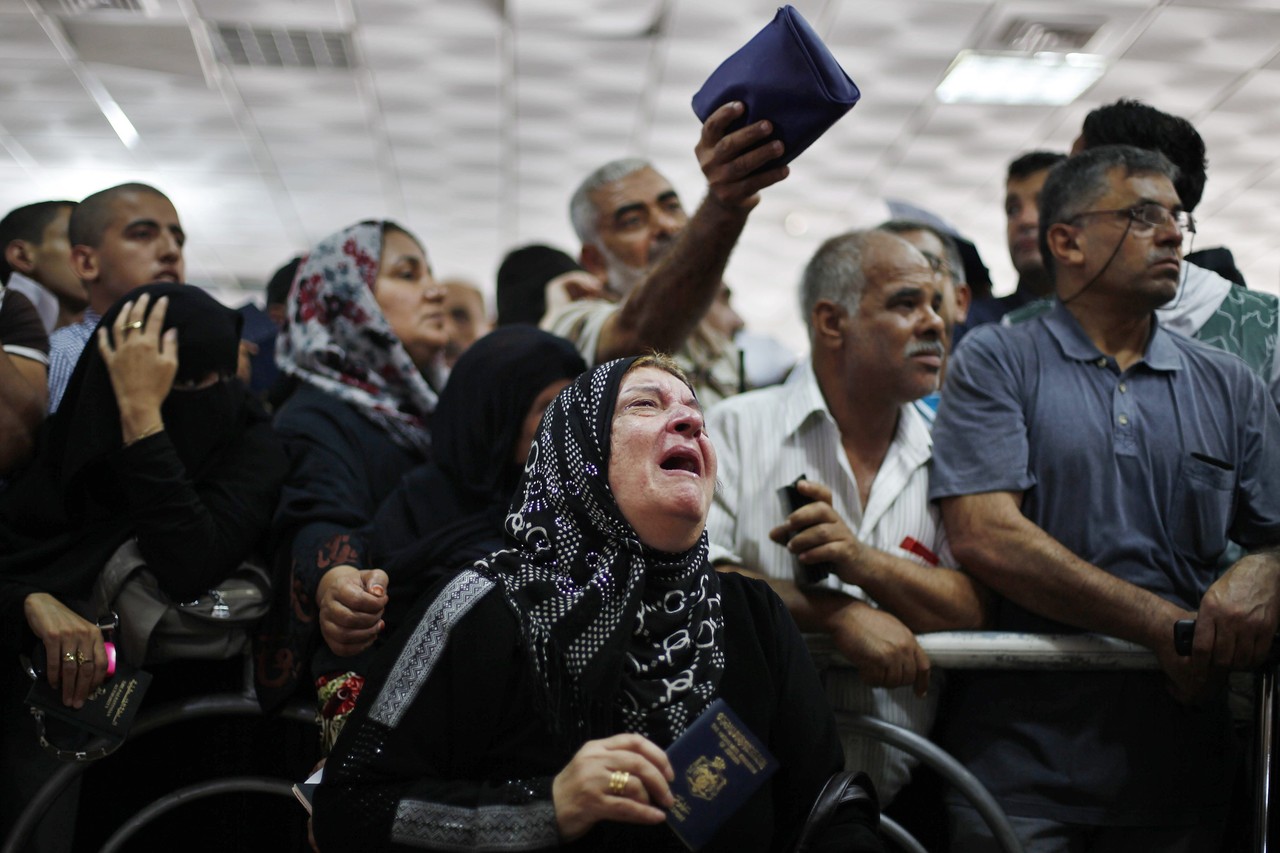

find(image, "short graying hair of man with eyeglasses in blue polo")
[1039,145,1178,274]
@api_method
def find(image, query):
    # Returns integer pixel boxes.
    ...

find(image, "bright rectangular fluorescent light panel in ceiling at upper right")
[934,50,1107,106]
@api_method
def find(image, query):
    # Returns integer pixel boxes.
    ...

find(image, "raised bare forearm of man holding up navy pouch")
[595,196,748,364]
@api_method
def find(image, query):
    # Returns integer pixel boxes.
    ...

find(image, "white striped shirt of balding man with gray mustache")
[707,359,955,802]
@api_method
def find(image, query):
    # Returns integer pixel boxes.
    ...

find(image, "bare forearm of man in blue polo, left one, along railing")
[942,492,1190,651]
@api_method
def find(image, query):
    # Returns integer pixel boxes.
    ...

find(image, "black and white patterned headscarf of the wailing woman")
[478,359,724,745]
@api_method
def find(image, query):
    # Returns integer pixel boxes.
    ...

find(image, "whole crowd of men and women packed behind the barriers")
[0,94,1280,853]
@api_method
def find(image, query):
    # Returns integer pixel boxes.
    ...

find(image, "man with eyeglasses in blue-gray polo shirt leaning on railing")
[929,146,1280,853]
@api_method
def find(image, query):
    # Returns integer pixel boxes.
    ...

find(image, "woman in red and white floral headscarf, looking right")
[257,216,445,707]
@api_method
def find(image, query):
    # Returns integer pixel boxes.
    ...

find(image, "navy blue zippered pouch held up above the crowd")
[694,5,861,168]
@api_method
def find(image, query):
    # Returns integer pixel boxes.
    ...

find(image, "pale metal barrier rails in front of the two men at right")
[806,631,1277,853]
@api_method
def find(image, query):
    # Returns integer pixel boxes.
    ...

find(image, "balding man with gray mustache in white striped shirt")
[707,225,983,803]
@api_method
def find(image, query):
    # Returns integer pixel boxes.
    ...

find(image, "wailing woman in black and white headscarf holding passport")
[314,356,883,853]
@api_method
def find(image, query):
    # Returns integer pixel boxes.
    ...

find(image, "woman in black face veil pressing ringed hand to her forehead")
[0,284,285,707]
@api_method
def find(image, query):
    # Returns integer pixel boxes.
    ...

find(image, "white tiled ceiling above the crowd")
[0,0,1280,347]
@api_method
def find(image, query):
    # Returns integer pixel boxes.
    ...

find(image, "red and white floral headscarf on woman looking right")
[275,222,436,452]
